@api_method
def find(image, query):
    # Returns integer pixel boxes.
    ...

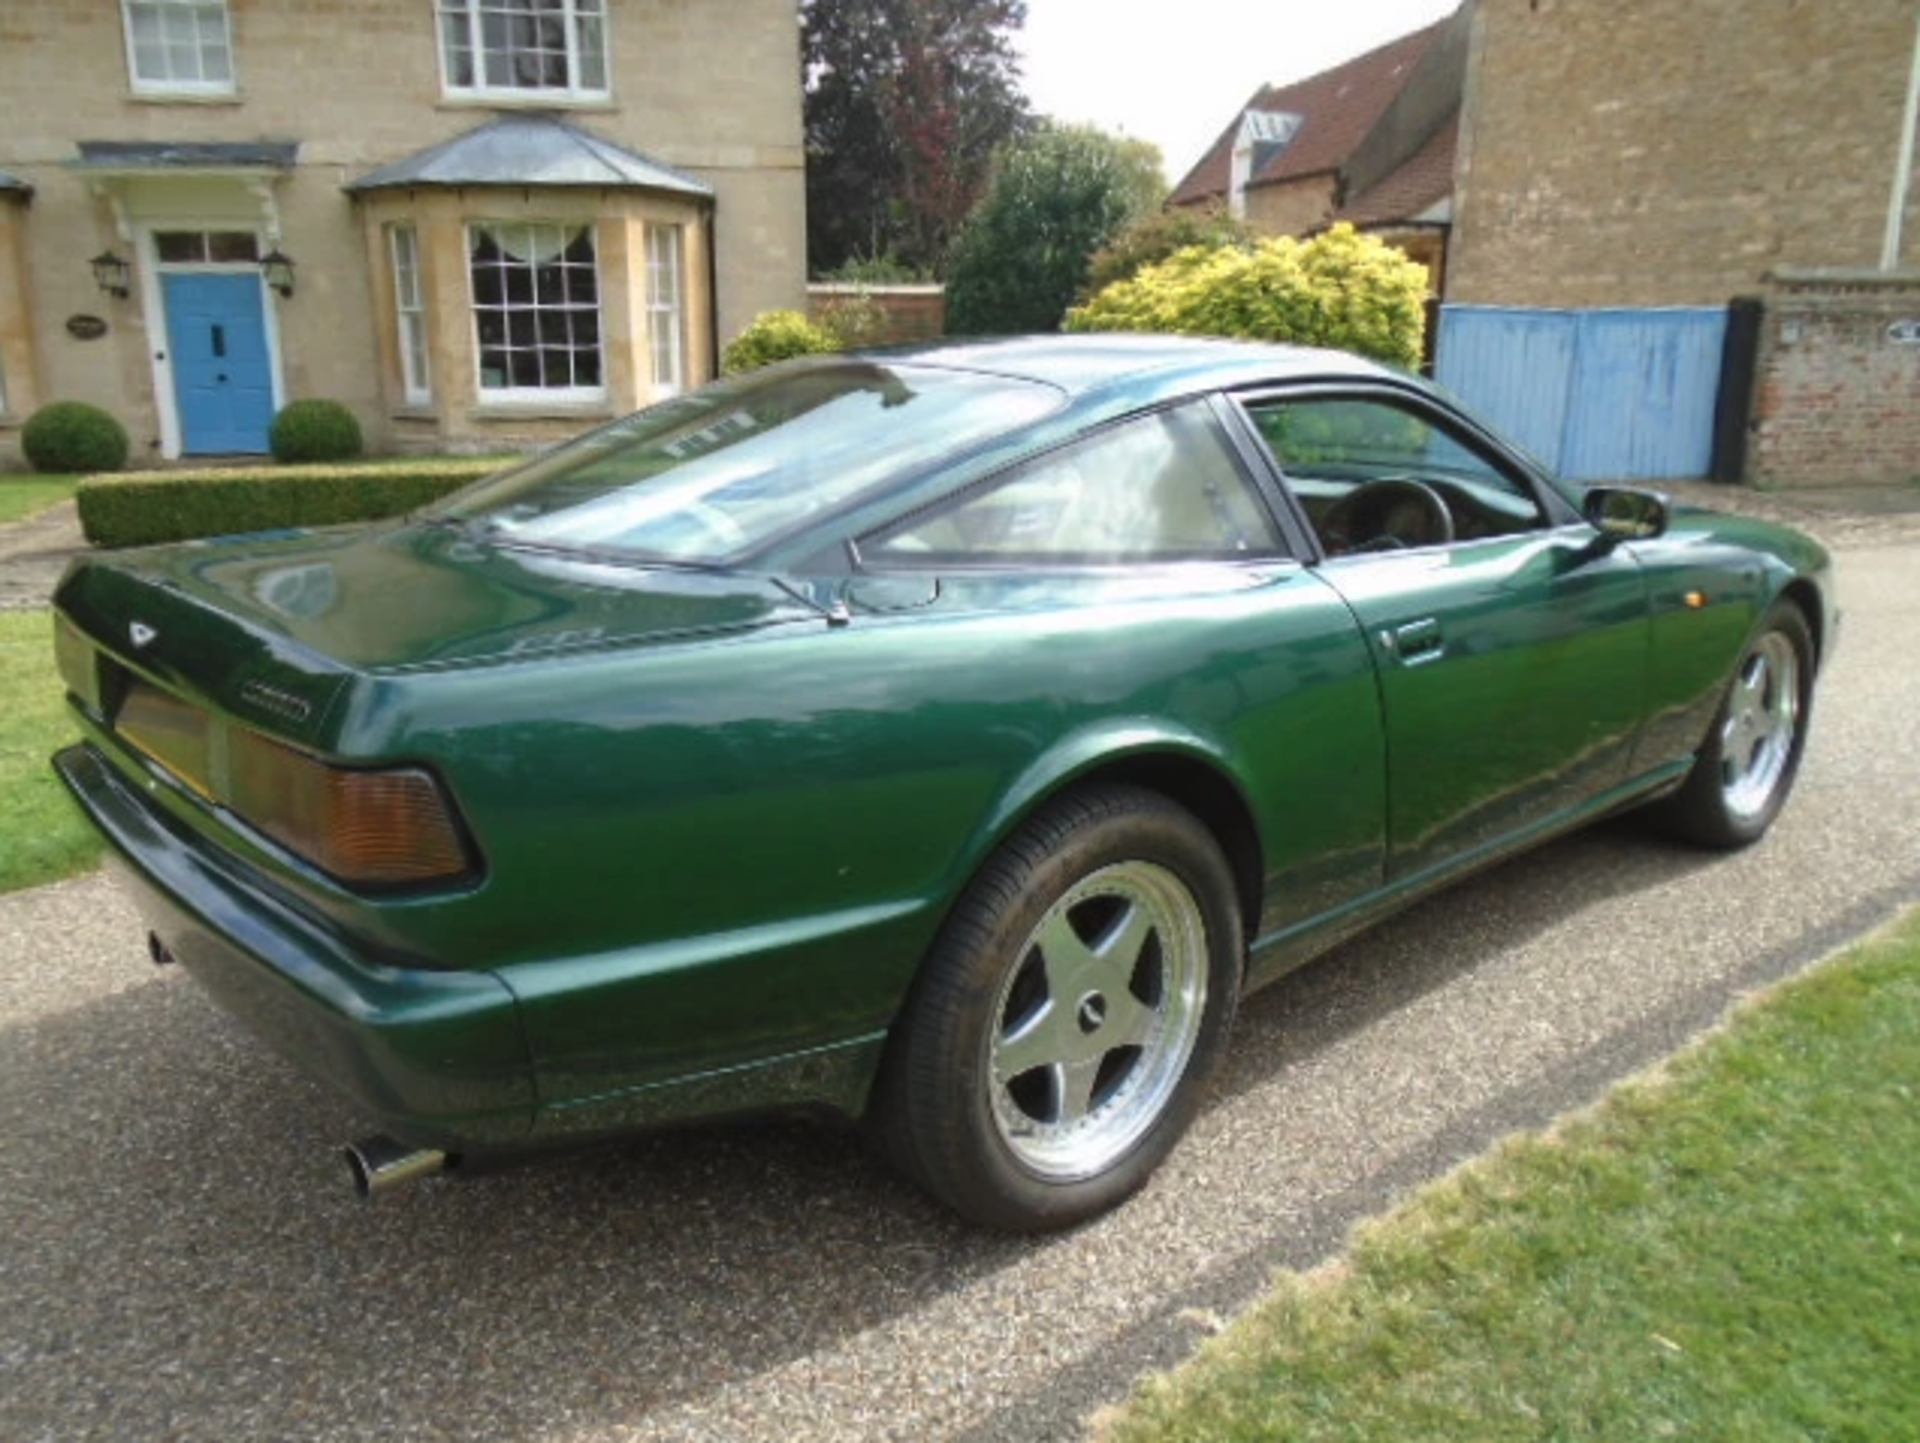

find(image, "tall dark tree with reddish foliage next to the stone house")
[801,0,1027,274]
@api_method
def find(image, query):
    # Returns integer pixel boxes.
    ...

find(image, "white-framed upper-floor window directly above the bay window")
[436,0,607,100]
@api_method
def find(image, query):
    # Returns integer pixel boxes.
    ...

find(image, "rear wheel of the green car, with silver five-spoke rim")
[874,787,1242,1232]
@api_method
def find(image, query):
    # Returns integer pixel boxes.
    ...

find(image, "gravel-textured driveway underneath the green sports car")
[11,498,1920,1443]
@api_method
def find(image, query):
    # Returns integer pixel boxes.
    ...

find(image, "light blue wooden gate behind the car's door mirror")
[1434,305,1726,482]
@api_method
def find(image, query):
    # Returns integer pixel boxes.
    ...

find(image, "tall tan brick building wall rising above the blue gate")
[1448,0,1920,307]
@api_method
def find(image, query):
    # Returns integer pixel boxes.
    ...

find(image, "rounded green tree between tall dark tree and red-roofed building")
[947,123,1165,336]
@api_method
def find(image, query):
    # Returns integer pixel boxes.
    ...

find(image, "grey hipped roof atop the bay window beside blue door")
[346,113,714,196]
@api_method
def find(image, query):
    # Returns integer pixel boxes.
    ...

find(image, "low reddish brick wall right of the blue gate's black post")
[1747,271,1920,487]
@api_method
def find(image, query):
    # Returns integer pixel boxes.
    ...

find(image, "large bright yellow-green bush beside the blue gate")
[1066,223,1427,368]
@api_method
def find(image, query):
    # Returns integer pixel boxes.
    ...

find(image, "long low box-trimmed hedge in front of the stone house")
[75,457,513,547]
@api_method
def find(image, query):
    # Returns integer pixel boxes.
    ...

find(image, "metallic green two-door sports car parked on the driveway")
[56,336,1836,1230]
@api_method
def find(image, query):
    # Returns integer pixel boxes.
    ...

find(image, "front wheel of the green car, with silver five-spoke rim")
[1655,601,1814,850]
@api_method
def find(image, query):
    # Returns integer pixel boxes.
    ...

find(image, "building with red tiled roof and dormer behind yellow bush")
[1167,6,1471,294]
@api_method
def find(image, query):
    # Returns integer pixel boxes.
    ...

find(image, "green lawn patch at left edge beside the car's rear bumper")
[0,610,102,892]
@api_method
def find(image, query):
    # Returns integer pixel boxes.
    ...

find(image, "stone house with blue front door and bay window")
[0,0,806,464]
